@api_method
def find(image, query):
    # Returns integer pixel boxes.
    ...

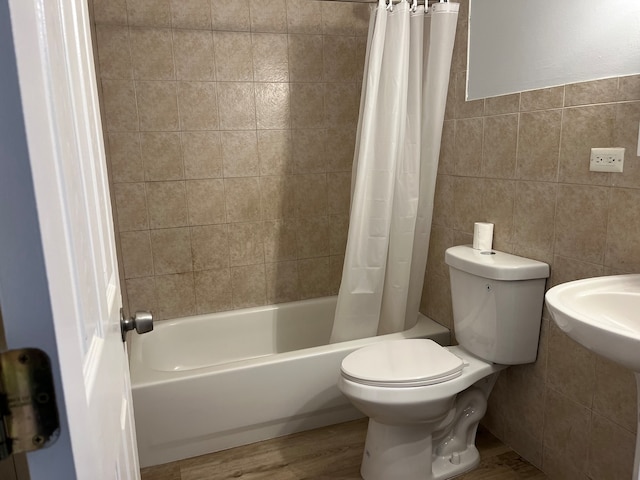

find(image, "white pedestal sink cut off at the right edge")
[545,275,640,480]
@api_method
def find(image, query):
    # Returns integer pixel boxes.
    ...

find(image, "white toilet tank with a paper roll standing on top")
[445,245,549,365]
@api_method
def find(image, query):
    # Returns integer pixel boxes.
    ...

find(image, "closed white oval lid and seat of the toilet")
[341,339,464,387]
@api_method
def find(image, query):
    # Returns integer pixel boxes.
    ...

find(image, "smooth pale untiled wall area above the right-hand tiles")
[467,0,640,100]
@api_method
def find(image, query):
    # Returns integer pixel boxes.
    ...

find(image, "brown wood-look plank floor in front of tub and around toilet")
[142,419,547,480]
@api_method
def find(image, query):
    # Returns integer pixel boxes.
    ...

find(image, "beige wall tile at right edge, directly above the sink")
[605,188,640,272]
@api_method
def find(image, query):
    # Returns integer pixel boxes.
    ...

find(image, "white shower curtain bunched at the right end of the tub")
[331,0,459,342]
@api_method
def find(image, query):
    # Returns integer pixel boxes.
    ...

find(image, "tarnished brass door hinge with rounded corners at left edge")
[0,348,60,460]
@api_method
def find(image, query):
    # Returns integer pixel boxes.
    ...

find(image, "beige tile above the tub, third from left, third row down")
[178,82,218,130]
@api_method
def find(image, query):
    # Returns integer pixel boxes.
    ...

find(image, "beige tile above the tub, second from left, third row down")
[136,82,178,131]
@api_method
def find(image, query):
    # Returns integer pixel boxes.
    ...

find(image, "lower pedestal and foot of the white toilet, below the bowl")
[360,419,480,480]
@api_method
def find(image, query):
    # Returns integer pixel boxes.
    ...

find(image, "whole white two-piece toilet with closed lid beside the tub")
[338,245,549,480]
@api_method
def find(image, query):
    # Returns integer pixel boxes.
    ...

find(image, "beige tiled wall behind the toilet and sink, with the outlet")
[422,0,640,480]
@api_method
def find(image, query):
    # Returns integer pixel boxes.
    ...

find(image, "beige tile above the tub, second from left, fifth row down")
[146,181,188,228]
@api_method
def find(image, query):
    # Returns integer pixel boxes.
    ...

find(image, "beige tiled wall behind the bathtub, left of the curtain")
[93,0,369,319]
